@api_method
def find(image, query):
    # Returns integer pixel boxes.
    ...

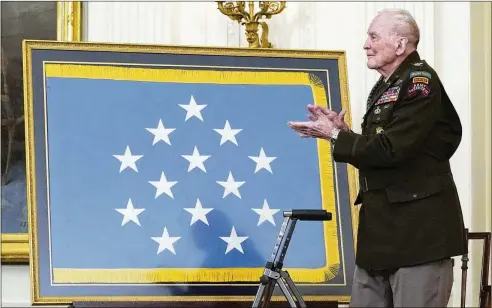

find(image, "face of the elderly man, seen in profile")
[364,14,397,70]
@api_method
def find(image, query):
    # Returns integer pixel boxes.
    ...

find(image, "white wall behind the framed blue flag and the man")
[2,2,491,307]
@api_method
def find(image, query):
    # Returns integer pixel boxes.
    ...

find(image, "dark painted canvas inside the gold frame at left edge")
[1,1,57,233]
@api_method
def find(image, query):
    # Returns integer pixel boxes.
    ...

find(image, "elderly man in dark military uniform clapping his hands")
[289,10,467,307]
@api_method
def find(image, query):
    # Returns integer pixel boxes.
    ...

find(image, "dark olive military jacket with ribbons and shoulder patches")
[333,51,467,270]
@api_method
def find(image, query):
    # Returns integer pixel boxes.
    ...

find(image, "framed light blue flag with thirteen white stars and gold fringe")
[24,41,357,303]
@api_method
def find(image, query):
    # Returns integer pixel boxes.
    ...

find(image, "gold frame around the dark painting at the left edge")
[1,1,82,263]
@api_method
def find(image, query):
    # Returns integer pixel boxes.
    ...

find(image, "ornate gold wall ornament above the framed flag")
[217,1,285,48]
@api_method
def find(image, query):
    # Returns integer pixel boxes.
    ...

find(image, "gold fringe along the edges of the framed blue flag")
[45,63,340,283]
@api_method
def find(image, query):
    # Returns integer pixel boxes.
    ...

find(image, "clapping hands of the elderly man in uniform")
[287,106,338,140]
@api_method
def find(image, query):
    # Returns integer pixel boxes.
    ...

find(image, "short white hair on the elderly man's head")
[378,8,420,47]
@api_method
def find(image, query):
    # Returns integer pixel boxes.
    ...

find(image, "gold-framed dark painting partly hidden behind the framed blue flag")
[1,1,81,263]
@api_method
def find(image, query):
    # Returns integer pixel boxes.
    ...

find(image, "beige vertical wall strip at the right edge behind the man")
[470,2,492,294]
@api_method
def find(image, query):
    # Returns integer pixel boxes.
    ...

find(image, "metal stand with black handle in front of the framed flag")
[253,210,332,308]
